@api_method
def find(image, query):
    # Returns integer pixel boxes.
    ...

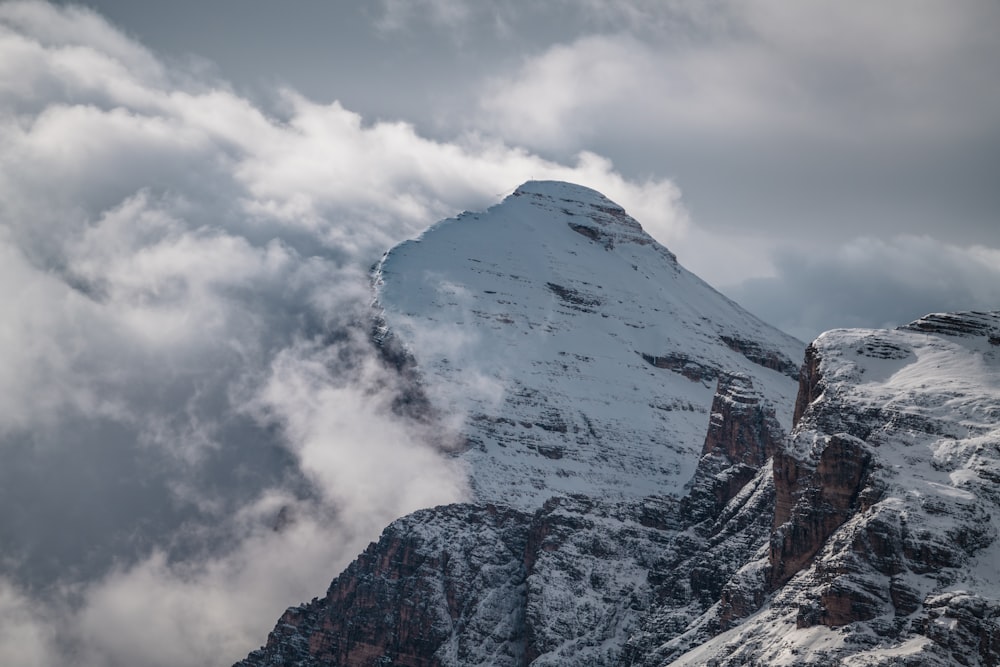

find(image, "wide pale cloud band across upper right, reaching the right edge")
[477,0,1000,150]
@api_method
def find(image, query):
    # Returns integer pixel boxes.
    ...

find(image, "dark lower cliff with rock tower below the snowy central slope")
[240,375,781,667]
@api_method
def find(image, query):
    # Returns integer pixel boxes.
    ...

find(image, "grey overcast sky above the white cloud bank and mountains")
[60,0,1000,339]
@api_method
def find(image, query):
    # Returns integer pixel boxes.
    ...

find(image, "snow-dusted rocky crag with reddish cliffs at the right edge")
[769,313,996,640]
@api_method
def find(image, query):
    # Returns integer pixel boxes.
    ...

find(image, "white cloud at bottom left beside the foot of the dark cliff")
[67,506,369,667]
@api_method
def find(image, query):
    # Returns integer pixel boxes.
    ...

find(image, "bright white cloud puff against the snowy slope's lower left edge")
[248,336,467,516]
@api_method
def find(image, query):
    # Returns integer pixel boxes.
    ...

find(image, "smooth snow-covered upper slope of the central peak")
[375,182,803,510]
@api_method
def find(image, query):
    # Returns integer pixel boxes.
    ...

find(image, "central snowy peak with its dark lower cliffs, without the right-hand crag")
[243,183,804,665]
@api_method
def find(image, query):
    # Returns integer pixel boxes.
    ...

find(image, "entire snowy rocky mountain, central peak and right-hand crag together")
[240,183,1000,667]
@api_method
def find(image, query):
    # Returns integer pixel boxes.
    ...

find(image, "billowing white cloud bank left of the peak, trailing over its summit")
[0,2,687,667]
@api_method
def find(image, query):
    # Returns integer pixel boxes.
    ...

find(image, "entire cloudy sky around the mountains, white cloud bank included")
[0,0,1000,667]
